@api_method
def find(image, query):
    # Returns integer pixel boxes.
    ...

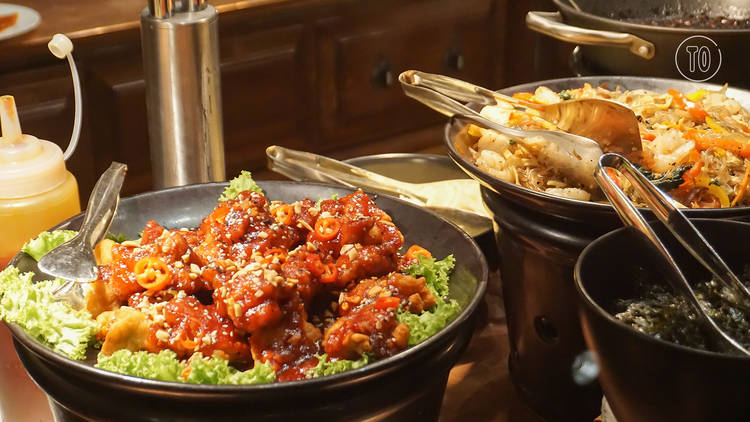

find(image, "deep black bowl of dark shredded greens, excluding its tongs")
[575,219,750,422]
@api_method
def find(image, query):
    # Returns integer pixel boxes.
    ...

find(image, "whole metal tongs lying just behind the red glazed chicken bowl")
[266,145,492,236]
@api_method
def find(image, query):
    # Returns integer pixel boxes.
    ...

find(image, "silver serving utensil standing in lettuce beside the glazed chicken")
[37,162,127,307]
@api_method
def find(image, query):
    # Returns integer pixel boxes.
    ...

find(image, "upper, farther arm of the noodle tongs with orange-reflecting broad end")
[403,70,643,155]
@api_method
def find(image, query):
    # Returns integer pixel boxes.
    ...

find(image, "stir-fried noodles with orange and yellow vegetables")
[468,84,750,208]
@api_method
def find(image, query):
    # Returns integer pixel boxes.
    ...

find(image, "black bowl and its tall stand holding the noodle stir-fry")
[444,76,750,421]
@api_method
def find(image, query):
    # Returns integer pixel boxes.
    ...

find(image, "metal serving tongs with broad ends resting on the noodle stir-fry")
[399,70,642,188]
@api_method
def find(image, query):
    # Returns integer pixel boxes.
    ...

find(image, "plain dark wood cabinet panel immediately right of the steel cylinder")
[221,25,316,180]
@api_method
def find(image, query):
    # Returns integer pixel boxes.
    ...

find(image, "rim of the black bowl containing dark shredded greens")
[573,218,750,361]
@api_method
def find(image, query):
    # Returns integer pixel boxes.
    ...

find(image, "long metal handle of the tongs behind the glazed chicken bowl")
[266,145,427,204]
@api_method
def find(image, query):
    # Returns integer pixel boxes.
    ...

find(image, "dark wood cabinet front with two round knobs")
[319,0,497,144]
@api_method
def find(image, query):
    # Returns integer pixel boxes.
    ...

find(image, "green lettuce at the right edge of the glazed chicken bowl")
[396,255,461,346]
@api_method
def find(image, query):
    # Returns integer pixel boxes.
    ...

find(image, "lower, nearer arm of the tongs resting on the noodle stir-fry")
[399,71,603,189]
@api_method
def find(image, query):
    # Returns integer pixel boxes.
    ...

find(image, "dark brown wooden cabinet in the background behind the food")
[0,0,505,198]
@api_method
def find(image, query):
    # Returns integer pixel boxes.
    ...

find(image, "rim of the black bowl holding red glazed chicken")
[6,181,489,394]
